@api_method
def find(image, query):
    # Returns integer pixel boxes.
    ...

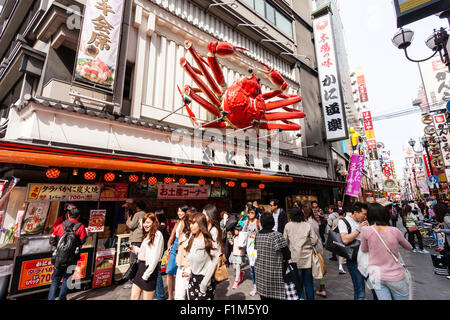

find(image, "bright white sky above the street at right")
[338,0,449,177]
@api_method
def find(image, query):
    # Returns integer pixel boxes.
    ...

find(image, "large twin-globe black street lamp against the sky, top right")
[392,28,450,70]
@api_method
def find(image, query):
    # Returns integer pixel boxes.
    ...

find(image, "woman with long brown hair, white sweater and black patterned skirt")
[184,213,219,300]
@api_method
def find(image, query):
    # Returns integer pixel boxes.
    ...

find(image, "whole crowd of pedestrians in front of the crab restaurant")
[49,199,450,300]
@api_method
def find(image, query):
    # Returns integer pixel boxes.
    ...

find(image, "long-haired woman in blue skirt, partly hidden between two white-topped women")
[166,205,189,300]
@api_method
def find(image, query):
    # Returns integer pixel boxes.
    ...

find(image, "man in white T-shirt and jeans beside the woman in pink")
[338,202,369,300]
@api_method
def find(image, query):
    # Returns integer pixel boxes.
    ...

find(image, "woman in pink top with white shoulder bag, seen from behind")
[361,203,412,300]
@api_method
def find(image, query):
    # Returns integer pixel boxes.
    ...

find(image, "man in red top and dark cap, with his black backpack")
[48,207,87,300]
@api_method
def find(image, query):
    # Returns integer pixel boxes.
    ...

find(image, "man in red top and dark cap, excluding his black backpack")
[48,207,87,300]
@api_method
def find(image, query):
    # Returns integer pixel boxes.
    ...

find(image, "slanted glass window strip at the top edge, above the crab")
[241,0,293,38]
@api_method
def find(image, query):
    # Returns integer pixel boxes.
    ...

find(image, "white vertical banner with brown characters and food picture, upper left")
[75,0,124,91]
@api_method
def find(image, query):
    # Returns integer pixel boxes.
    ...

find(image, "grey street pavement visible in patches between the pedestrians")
[61,221,450,300]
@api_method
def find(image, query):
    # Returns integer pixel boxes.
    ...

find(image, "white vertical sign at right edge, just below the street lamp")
[419,56,450,111]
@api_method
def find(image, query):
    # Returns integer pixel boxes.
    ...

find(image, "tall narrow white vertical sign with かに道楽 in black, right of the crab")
[314,14,348,141]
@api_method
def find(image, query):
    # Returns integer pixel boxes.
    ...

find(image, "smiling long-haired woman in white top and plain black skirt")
[128,213,164,300]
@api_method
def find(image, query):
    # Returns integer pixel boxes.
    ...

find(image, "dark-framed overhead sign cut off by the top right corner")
[394,0,449,28]
